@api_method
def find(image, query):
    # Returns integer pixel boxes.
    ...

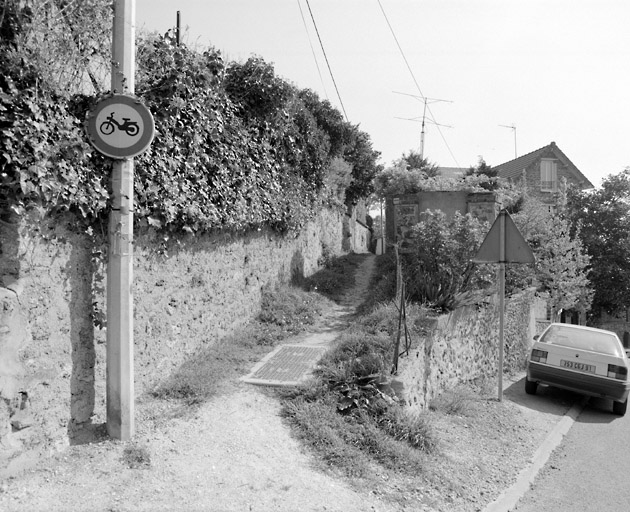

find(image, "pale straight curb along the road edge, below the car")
[483,398,588,512]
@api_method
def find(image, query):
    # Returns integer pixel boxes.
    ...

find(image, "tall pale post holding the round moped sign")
[107,0,136,441]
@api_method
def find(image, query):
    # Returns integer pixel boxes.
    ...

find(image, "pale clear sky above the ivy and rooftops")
[136,0,630,186]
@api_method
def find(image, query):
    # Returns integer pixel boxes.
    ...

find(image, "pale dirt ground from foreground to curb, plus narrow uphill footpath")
[0,256,571,512]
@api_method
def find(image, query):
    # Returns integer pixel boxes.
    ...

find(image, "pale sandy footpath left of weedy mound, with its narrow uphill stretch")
[0,256,402,512]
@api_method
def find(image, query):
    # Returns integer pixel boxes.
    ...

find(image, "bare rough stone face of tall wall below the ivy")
[0,211,352,466]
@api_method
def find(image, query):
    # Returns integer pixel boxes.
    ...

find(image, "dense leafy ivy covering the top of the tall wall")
[0,0,379,232]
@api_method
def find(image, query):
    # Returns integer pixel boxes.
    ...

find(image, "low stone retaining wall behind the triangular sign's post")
[398,291,543,411]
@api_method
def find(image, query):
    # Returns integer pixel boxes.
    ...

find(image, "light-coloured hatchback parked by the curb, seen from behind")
[525,323,630,416]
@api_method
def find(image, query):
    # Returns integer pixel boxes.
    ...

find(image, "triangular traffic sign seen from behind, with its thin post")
[473,209,535,402]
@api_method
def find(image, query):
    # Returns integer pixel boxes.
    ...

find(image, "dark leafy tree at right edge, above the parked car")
[567,168,630,316]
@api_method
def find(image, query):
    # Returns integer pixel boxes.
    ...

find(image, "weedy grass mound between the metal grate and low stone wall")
[281,320,437,478]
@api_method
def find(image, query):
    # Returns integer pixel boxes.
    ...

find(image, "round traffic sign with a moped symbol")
[85,94,155,159]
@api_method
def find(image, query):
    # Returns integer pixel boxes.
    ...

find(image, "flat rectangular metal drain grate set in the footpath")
[242,345,326,386]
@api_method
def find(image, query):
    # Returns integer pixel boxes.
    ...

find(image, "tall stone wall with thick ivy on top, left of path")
[0,0,379,467]
